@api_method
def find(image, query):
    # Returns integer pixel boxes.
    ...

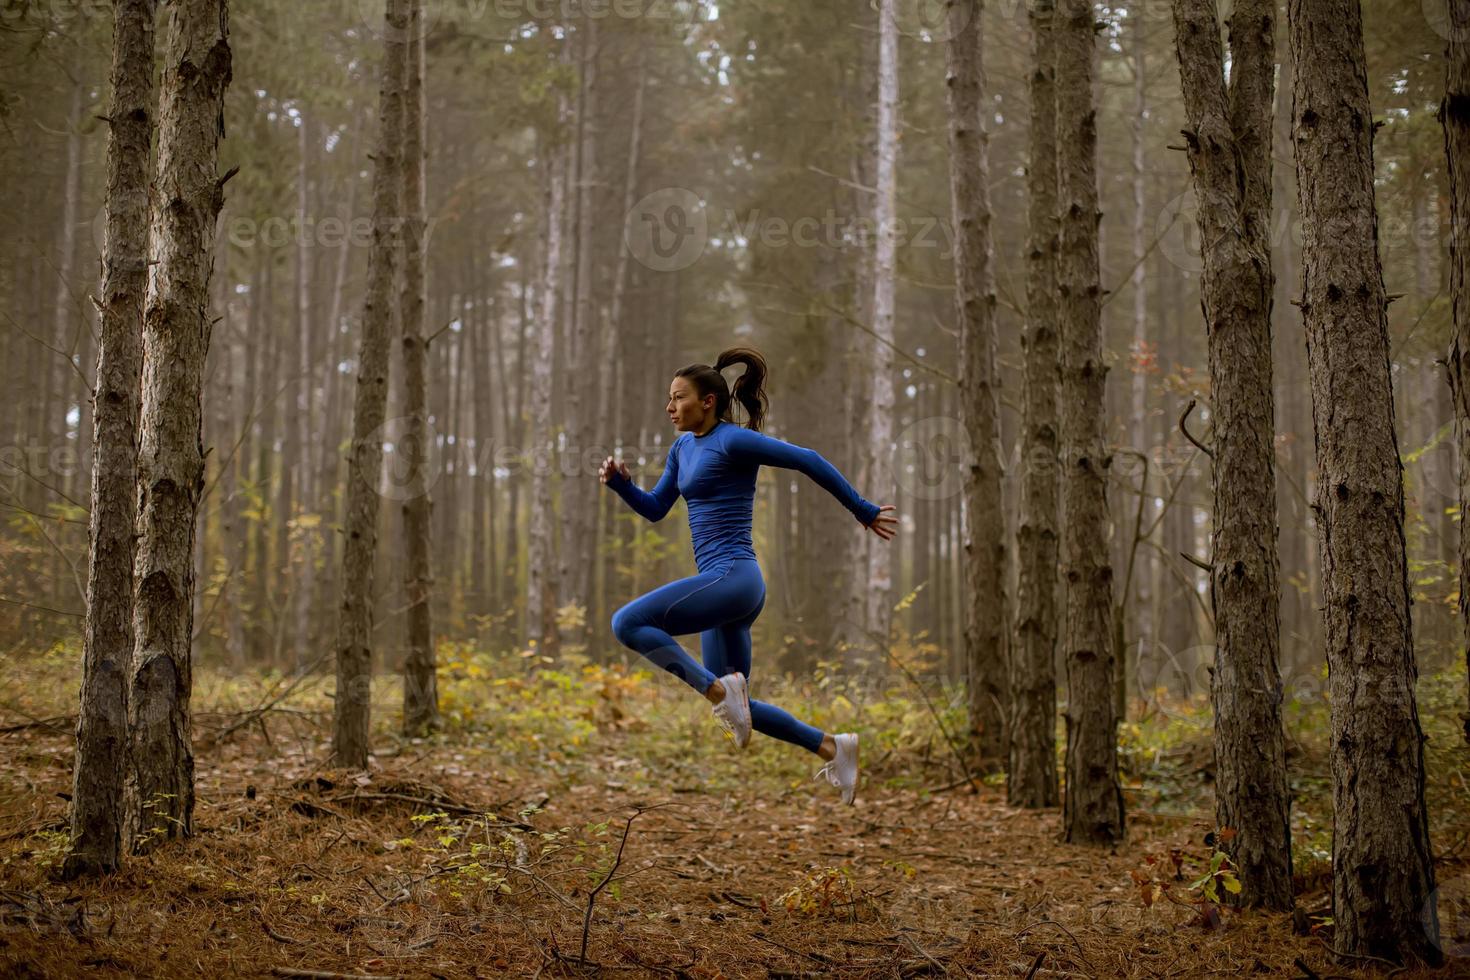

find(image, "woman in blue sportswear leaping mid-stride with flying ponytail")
[598,347,898,804]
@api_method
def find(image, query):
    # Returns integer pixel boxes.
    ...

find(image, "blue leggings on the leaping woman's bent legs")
[613,558,822,752]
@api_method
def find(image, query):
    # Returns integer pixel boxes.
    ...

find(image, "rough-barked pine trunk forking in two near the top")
[1173,0,1292,911]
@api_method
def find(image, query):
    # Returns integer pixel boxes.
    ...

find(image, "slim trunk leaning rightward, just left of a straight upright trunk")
[332,0,409,768]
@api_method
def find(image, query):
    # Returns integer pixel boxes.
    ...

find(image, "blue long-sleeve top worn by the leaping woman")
[607,422,879,572]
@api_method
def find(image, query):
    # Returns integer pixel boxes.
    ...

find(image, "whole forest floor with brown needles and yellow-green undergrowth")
[0,643,1470,979]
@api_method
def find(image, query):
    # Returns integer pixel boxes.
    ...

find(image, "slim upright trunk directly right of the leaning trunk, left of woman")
[397,0,435,736]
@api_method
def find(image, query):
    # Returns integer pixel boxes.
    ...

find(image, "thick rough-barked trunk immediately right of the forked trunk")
[1289,0,1439,962]
